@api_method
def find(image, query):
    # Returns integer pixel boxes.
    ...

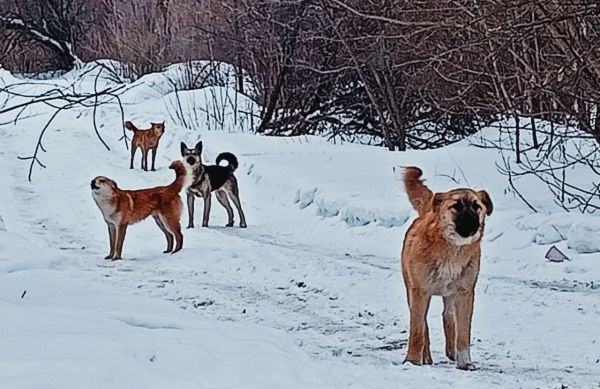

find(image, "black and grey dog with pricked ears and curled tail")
[180,142,246,228]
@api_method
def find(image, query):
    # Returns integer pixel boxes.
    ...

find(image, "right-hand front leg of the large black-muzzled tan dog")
[455,290,475,370]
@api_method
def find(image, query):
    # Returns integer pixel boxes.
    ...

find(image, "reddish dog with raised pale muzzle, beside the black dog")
[91,161,191,260]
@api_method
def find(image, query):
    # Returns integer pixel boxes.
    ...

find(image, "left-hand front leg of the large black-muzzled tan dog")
[404,289,431,365]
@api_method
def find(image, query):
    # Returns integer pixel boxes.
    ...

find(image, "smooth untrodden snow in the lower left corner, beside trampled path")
[0,232,342,388]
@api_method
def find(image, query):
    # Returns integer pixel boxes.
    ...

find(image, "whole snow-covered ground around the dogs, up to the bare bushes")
[0,63,600,388]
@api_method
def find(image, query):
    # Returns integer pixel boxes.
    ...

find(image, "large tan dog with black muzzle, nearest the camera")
[402,167,493,370]
